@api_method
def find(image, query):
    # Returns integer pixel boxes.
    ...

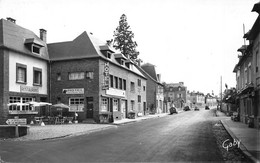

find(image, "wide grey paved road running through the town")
[0,109,222,162]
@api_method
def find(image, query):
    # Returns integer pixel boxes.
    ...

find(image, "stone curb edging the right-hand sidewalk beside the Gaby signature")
[220,120,260,163]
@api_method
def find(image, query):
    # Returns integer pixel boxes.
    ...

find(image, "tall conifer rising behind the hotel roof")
[113,14,139,61]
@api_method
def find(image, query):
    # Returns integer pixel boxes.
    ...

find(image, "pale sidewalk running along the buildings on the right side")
[217,111,260,162]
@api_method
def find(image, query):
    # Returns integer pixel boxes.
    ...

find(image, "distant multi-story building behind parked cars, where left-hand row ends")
[165,82,187,108]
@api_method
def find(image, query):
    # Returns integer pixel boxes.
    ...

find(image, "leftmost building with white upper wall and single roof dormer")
[0,18,49,124]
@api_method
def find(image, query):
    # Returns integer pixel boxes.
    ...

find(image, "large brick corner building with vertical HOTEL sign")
[48,32,147,122]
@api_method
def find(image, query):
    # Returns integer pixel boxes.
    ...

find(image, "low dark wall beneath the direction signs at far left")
[0,125,30,138]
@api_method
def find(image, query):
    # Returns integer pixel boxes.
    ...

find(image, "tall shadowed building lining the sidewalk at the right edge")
[233,3,260,127]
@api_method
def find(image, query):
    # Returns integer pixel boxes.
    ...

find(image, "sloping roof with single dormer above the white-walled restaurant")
[0,19,49,60]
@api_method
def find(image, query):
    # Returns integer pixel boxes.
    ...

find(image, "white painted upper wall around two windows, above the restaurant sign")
[9,51,47,95]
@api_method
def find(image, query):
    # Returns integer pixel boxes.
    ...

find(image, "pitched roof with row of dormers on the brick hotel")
[48,31,146,79]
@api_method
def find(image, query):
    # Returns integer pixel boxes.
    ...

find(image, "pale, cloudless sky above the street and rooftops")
[0,0,259,95]
